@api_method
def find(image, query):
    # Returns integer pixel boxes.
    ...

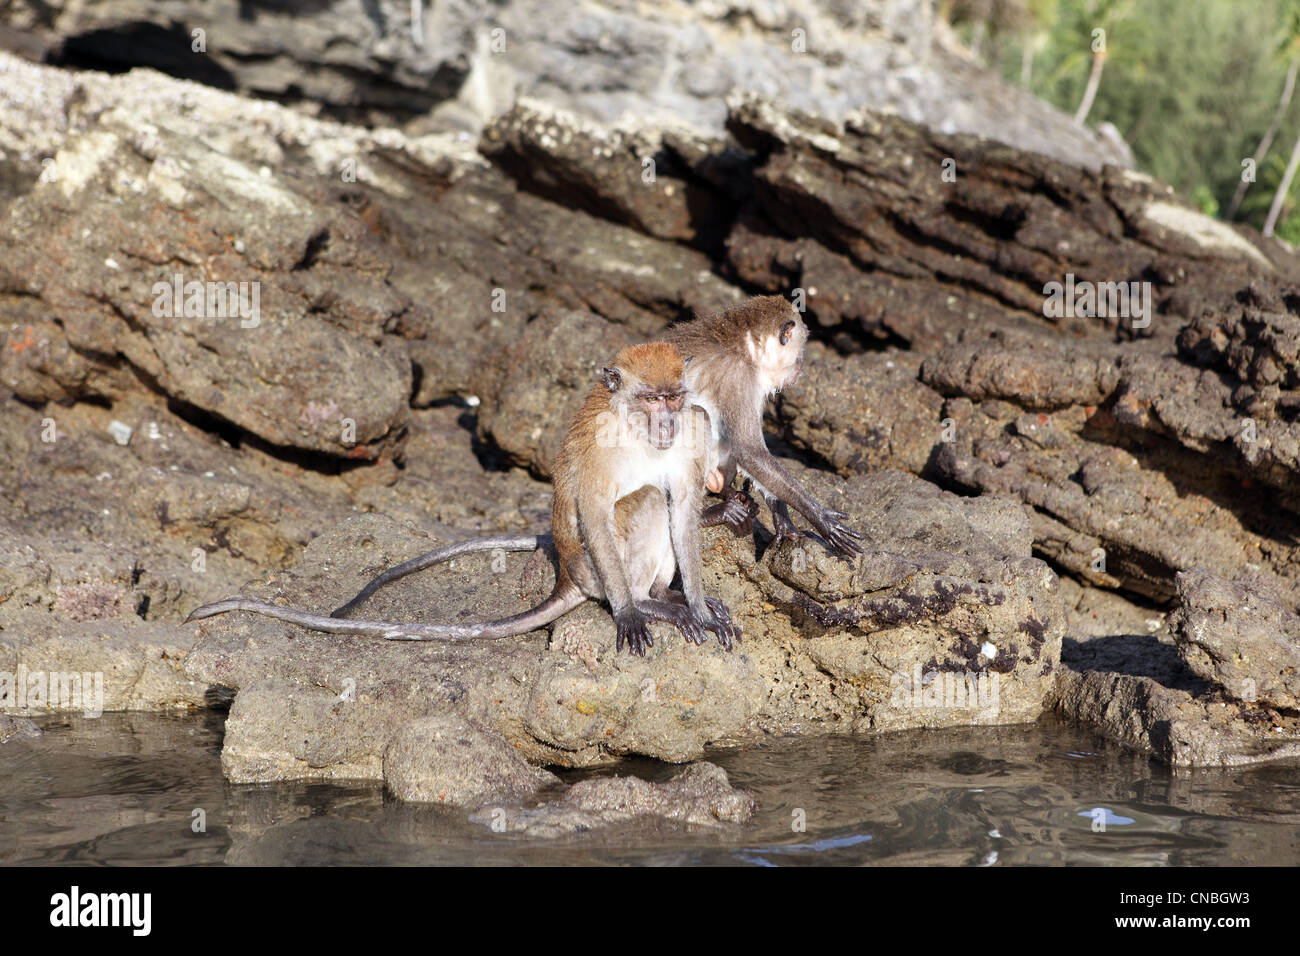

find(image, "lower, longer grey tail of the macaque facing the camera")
[185,582,585,641]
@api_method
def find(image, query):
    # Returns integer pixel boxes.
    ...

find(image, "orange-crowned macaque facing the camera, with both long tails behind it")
[187,342,740,656]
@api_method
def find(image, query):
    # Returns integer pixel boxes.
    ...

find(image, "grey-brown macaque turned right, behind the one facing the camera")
[664,295,862,558]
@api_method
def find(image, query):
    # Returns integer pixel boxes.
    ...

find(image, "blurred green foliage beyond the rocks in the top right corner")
[963,0,1300,235]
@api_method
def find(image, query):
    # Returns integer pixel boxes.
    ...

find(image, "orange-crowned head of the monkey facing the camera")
[601,342,686,451]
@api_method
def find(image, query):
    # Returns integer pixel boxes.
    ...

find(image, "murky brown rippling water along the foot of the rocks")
[0,713,1300,866]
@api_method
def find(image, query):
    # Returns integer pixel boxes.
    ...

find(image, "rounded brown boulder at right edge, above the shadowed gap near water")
[1173,568,1300,710]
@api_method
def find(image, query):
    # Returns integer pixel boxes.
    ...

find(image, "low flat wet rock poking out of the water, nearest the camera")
[471,761,757,838]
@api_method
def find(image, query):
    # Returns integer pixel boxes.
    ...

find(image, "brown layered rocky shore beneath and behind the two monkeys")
[0,46,1300,816]
